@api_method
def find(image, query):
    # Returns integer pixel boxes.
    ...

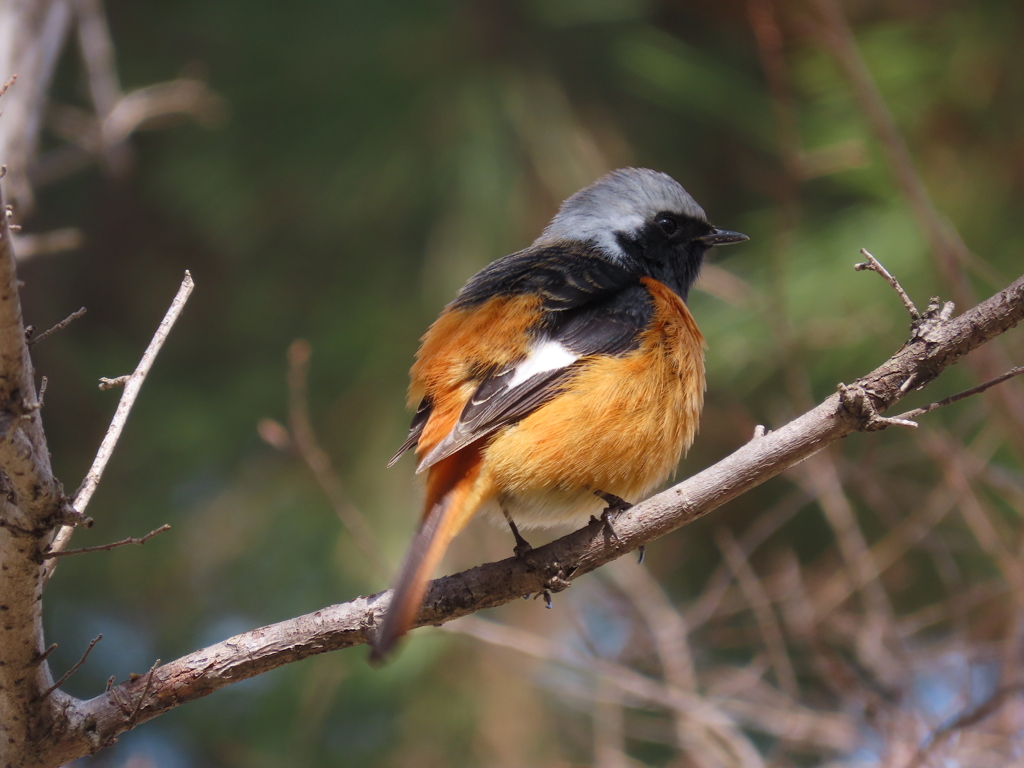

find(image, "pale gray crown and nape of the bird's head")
[534,168,708,254]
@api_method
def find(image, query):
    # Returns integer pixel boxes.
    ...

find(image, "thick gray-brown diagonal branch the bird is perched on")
[27,276,1024,768]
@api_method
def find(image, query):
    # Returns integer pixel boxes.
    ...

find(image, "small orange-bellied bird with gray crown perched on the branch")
[371,168,749,660]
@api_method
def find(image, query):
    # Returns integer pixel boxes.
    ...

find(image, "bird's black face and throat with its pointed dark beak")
[616,211,748,300]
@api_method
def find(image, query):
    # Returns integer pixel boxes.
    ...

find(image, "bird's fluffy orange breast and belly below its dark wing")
[482,279,705,526]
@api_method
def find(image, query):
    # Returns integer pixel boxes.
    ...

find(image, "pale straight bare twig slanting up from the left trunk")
[43,269,196,584]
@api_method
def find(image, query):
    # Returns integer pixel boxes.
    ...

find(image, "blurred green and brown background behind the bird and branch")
[0,0,1024,768]
